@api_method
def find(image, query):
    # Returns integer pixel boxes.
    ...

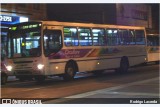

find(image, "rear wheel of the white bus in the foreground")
[119,57,129,73]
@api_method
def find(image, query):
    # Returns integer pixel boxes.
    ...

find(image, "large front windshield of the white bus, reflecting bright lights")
[8,24,41,58]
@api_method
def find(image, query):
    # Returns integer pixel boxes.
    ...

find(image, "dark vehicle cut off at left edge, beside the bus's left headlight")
[0,62,8,85]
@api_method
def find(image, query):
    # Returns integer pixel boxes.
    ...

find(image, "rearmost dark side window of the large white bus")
[135,30,145,45]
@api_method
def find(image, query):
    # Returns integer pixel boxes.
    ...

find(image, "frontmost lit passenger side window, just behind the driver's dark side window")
[63,27,79,46]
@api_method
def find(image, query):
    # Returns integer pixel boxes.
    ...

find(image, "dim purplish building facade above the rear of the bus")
[116,4,152,28]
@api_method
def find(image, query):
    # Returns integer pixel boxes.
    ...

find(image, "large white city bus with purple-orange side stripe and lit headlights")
[7,21,146,82]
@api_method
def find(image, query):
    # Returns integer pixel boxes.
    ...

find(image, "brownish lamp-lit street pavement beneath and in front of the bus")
[1,64,159,104]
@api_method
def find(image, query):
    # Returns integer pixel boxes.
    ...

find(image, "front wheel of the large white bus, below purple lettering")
[63,61,76,81]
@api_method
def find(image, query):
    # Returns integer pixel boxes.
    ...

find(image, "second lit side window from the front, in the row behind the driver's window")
[78,28,92,46]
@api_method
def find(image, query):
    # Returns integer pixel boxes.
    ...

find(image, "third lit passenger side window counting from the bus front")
[92,29,105,46]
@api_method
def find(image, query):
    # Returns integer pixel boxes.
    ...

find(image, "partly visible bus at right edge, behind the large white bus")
[147,34,160,64]
